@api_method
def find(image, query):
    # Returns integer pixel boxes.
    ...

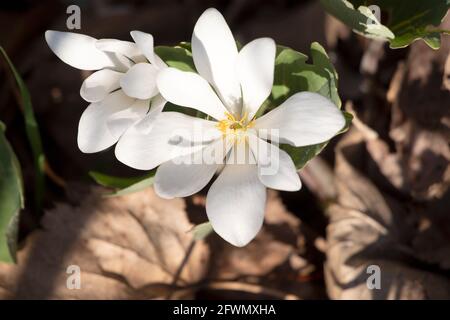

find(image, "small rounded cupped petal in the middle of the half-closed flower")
[120,63,158,99]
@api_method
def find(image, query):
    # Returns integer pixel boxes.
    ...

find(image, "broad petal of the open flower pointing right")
[255,92,345,147]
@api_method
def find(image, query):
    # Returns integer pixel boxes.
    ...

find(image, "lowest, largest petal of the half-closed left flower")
[78,90,135,153]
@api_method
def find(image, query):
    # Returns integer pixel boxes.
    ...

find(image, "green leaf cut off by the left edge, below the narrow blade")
[0,122,24,262]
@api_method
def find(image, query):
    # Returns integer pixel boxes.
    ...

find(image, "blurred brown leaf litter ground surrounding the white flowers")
[0,0,450,299]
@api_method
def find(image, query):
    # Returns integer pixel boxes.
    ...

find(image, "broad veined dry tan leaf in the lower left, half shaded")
[0,188,209,299]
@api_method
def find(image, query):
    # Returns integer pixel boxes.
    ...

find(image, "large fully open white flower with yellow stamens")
[116,9,345,246]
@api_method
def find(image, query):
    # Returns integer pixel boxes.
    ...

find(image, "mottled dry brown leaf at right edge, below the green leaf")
[355,39,450,201]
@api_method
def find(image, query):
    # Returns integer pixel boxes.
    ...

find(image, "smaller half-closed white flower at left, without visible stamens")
[45,31,167,153]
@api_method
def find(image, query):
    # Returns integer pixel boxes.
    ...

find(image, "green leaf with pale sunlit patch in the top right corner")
[320,0,450,49]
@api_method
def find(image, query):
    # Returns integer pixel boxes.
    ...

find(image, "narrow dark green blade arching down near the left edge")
[0,47,45,210]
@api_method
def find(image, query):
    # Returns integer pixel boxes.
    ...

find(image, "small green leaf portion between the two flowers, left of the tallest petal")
[155,42,196,72]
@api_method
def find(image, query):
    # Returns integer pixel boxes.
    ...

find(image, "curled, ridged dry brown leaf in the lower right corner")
[325,129,450,299]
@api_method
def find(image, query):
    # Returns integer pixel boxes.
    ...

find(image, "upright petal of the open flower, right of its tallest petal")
[238,38,276,119]
